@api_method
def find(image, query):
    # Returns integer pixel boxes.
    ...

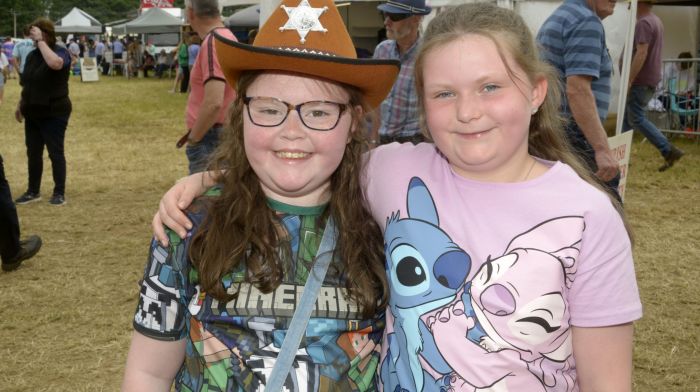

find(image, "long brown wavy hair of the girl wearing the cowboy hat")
[189,72,388,317]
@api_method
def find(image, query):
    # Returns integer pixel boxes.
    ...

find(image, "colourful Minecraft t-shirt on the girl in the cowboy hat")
[134,200,384,391]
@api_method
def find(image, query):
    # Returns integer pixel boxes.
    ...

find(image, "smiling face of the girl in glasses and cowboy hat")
[242,73,354,206]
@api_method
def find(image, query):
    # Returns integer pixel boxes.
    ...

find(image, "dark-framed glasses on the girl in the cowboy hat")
[243,97,350,131]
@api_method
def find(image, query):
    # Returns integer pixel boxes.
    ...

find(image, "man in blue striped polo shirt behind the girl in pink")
[537,0,620,198]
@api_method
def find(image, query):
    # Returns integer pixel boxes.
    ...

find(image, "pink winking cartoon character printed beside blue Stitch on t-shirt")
[428,216,585,391]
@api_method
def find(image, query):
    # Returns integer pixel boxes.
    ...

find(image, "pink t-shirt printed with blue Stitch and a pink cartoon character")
[367,143,642,391]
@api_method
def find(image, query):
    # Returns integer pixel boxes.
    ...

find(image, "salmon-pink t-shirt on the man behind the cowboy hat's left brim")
[186,27,236,129]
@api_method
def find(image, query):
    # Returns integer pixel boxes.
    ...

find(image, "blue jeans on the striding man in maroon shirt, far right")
[624,86,671,157]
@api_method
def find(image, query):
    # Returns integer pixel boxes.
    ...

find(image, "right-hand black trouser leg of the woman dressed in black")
[41,117,68,196]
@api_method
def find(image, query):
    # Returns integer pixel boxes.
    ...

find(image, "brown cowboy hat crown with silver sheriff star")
[253,0,357,59]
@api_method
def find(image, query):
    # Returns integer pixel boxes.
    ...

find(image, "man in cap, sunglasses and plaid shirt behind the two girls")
[370,0,431,144]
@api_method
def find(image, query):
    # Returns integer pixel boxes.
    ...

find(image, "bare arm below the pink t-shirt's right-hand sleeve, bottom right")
[572,323,634,392]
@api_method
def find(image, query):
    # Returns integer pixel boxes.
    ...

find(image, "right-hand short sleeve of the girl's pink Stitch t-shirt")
[569,200,642,327]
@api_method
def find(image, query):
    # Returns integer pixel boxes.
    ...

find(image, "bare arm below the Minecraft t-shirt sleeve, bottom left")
[122,331,186,392]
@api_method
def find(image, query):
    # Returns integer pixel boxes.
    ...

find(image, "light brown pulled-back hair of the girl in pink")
[415,3,631,228]
